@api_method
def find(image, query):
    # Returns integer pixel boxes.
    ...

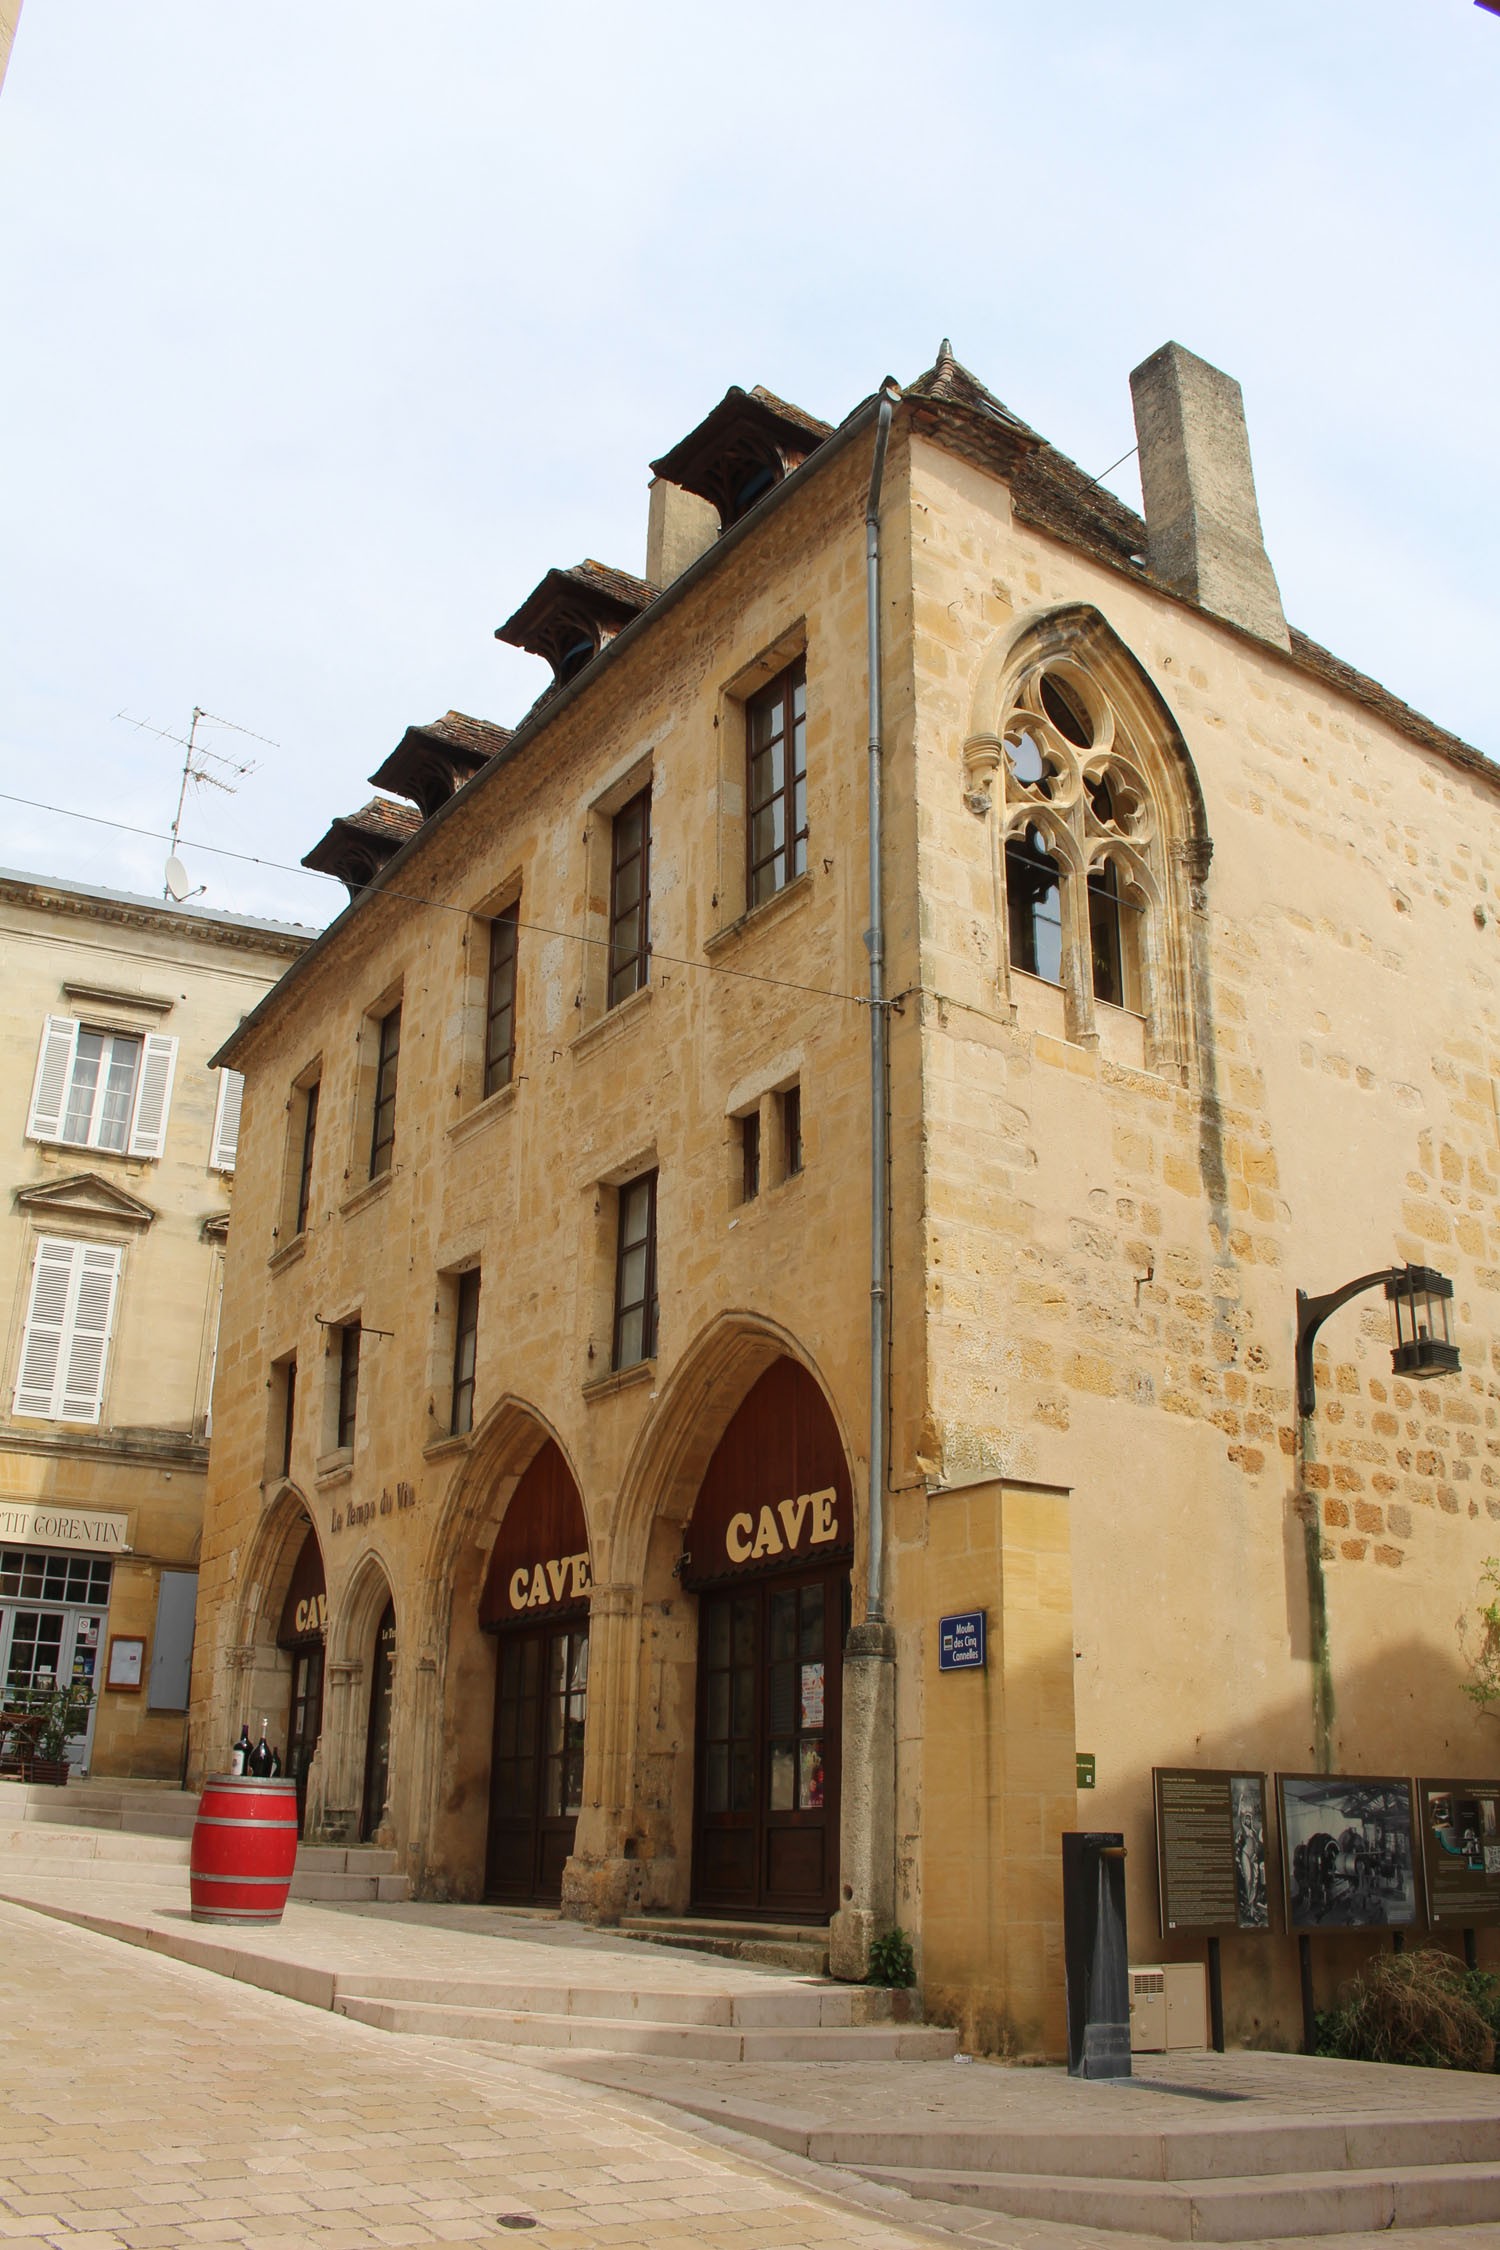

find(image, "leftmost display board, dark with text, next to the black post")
[1151,1766,1271,1937]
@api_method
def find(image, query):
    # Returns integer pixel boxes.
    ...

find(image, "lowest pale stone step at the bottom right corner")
[848,2135,1500,2243]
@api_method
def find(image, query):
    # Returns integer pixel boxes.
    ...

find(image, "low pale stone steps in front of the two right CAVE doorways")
[335,1987,958,2063]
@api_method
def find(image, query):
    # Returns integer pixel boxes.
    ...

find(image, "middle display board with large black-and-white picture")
[1275,1773,1417,1931]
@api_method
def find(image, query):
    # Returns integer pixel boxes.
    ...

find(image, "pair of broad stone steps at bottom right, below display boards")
[827,2115,1500,2243]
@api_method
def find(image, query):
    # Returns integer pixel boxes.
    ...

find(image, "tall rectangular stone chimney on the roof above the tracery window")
[1131,344,1291,648]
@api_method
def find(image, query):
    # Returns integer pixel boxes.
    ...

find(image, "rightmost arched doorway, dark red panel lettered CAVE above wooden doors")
[681,1359,855,1922]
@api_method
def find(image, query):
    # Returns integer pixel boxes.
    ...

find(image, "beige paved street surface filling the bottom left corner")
[0,1906,940,2250]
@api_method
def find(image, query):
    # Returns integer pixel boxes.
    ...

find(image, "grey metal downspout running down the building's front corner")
[864,378,895,1622]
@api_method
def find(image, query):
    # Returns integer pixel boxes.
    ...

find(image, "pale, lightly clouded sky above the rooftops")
[0,0,1500,923]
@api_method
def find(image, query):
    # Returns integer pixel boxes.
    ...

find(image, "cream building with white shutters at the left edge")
[0,873,310,1780]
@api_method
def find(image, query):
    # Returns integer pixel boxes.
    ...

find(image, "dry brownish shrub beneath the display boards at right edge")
[1316,1946,1500,2070]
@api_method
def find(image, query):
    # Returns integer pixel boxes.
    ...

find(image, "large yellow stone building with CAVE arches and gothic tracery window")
[193,347,1500,2052]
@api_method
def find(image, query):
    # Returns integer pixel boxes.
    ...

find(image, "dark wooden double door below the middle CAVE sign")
[484,1616,589,1906]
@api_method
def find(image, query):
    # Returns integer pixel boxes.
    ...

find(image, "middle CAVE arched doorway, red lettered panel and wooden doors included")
[479,1438,591,1904]
